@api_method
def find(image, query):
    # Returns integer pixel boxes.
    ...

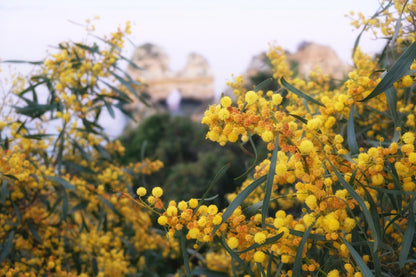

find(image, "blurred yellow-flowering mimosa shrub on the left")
[0,21,179,276]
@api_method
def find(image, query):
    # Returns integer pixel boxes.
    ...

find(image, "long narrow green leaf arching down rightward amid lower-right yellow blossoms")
[328,163,380,253]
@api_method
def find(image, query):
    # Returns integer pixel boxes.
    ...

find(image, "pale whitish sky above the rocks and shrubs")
[0,0,381,135]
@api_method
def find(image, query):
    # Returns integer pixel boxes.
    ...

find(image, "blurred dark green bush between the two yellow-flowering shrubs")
[121,114,266,206]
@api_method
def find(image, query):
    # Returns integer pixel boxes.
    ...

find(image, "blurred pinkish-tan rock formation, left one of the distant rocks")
[126,43,214,118]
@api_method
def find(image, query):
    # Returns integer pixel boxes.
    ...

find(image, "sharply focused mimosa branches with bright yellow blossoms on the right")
[152,1,416,277]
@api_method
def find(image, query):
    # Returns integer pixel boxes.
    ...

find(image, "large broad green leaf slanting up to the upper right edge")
[360,41,416,102]
